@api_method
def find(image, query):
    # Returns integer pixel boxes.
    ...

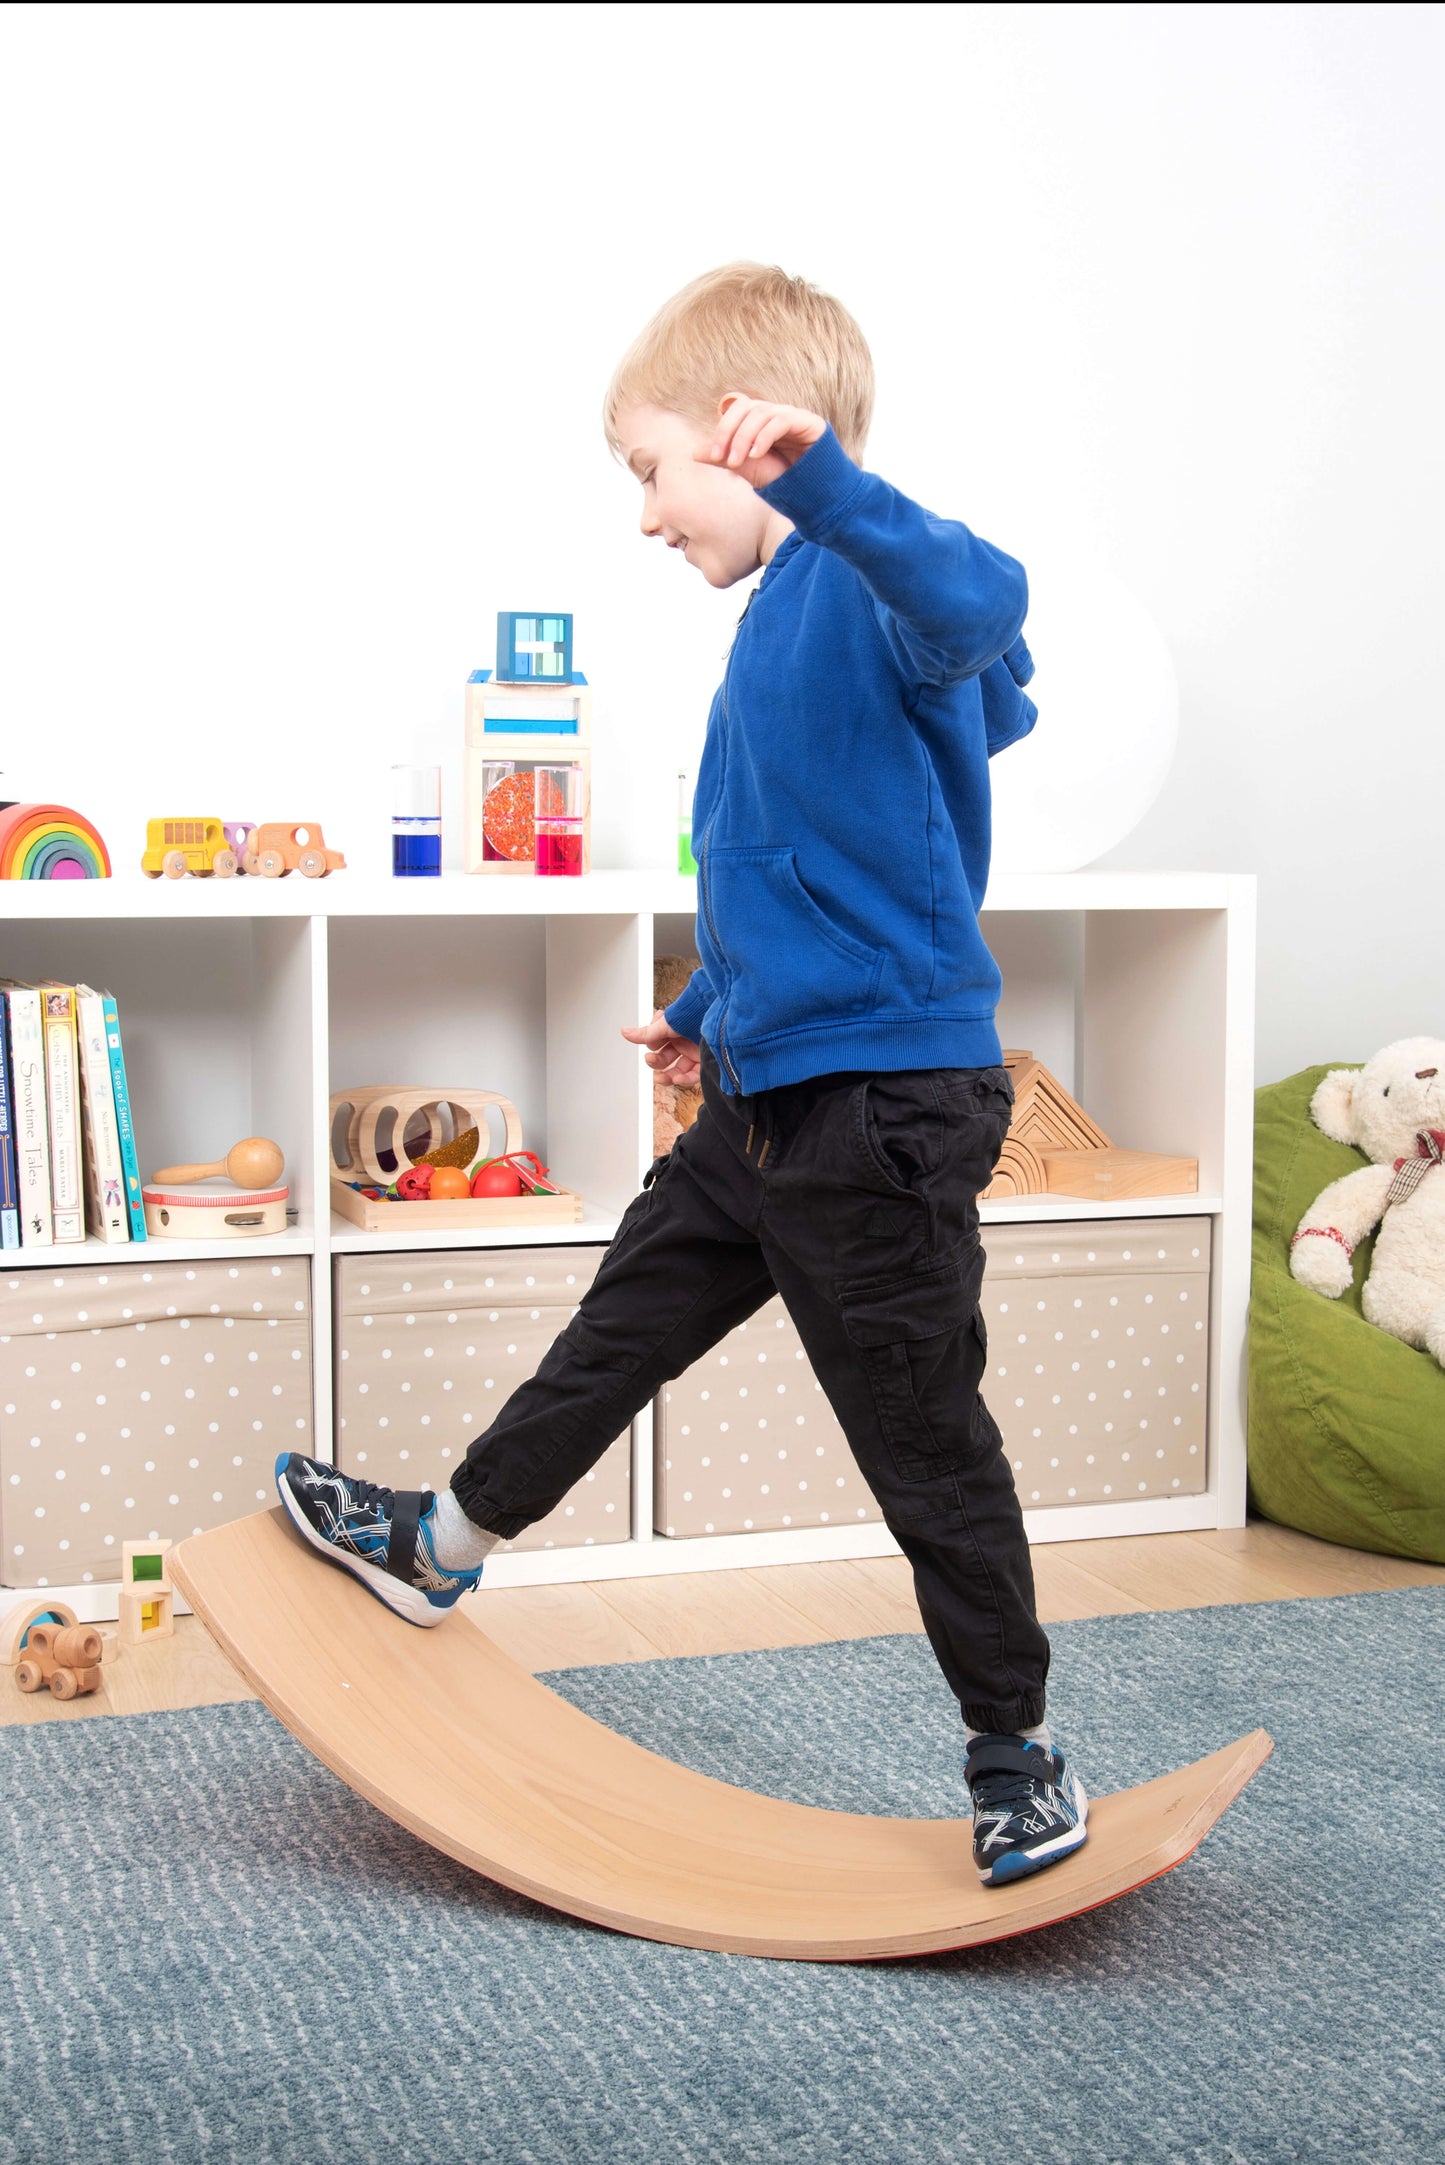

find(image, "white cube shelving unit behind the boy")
[0,870,1254,1615]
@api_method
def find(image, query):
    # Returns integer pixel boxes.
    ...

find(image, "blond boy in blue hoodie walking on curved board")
[277,264,1088,1886]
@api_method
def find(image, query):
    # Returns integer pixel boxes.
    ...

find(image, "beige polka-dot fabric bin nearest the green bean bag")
[979,1217,1211,1511]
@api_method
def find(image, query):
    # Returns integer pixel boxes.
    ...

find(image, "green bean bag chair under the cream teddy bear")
[1248,1061,1445,1563]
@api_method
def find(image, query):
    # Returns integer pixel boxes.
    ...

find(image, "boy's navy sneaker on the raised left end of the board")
[275,1451,483,1624]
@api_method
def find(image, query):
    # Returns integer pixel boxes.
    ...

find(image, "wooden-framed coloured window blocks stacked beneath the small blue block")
[461,669,591,877]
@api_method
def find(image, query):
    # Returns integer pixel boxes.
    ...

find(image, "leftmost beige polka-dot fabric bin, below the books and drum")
[0,1256,312,1587]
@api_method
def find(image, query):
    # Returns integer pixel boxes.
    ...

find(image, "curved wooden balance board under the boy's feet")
[171,1509,1272,1961]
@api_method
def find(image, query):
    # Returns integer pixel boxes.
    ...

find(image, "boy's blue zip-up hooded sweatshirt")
[667,429,1038,1095]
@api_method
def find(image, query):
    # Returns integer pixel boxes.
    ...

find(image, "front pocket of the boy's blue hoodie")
[708,849,886,1039]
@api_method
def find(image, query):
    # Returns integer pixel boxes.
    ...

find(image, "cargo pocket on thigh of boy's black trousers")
[838,1247,986,1481]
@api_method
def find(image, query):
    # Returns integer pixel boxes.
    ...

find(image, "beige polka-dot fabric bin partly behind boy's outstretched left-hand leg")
[336,1243,633,1554]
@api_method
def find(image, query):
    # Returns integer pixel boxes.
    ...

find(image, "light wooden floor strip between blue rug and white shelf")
[0,1520,1445,1726]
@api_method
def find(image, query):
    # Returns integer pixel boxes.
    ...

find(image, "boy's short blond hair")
[602,262,873,459]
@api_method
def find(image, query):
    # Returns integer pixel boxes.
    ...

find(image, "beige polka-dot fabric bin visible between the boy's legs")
[652,1295,882,1539]
